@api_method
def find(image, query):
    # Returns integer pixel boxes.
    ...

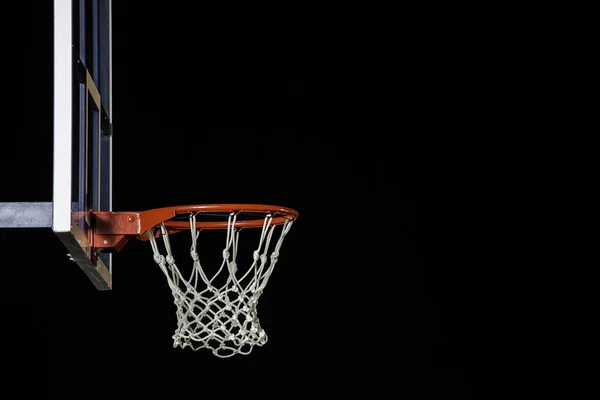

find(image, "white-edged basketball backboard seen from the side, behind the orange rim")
[52,0,112,290]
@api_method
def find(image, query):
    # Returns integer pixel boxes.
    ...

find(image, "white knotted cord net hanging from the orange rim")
[148,213,293,357]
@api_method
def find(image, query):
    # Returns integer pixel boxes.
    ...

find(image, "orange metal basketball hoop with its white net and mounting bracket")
[89,204,298,358]
